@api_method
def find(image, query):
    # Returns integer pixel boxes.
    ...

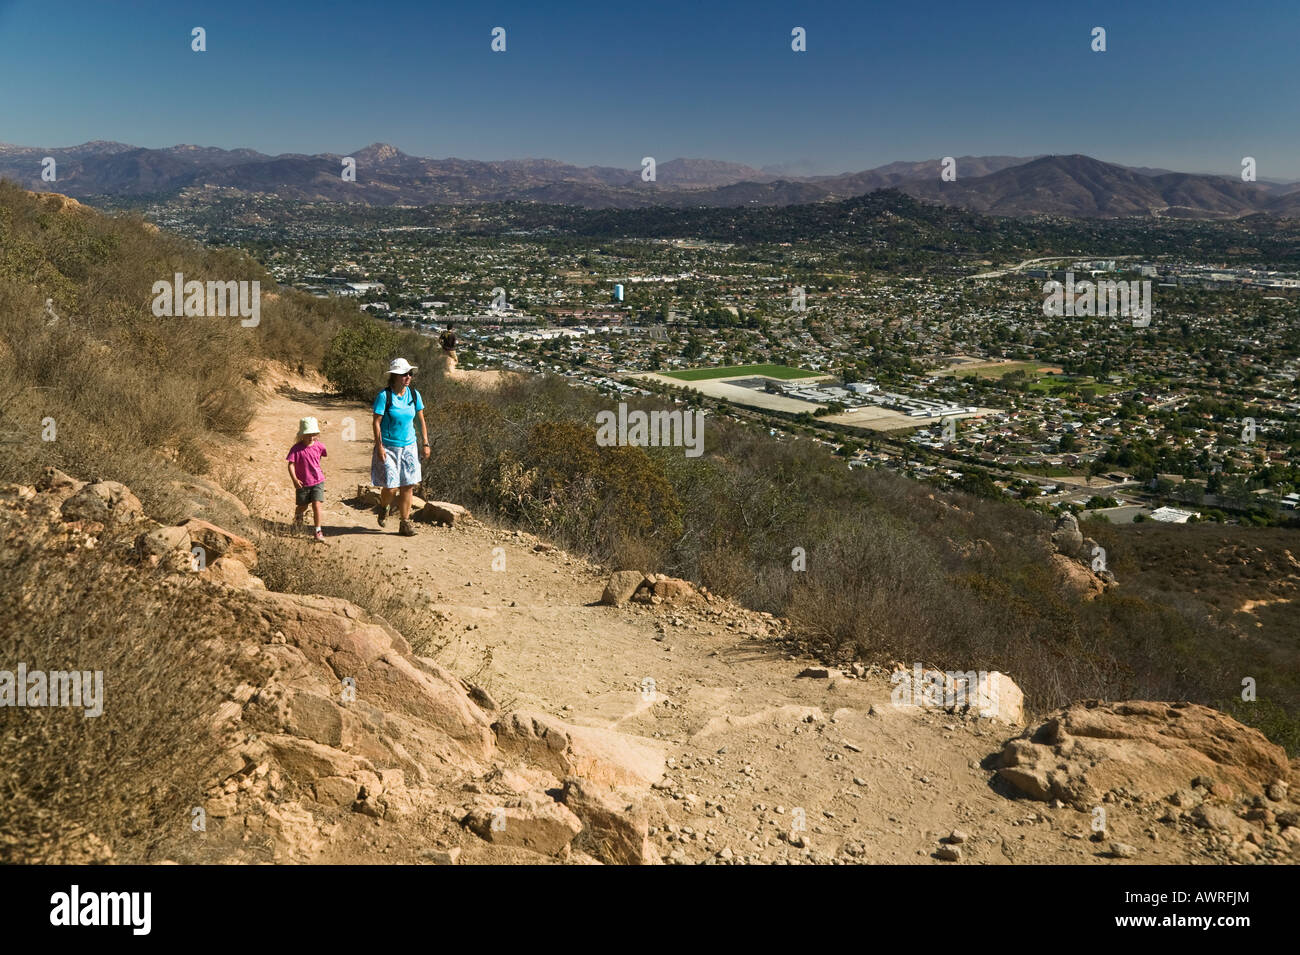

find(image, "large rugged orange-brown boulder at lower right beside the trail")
[997,700,1290,809]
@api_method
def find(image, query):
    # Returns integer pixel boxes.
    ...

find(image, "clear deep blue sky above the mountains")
[0,0,1300,178]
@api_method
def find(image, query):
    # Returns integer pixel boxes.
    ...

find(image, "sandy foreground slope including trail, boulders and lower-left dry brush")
[0,361,1300,864]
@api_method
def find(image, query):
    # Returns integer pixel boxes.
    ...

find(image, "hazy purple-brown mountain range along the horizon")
[0,142,1300,218]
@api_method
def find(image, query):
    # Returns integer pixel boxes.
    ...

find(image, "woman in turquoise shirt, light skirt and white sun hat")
[371,359,430,537]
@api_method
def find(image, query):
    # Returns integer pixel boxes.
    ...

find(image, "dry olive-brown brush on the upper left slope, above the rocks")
[0,183,343,490]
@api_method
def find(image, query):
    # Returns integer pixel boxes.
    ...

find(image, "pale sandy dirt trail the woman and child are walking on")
[217,372,1209,864]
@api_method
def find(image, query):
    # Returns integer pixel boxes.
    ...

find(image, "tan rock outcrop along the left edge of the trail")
[0,469,664,863]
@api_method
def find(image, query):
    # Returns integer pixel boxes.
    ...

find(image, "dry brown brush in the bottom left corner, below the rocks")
[0,511,264,863]
